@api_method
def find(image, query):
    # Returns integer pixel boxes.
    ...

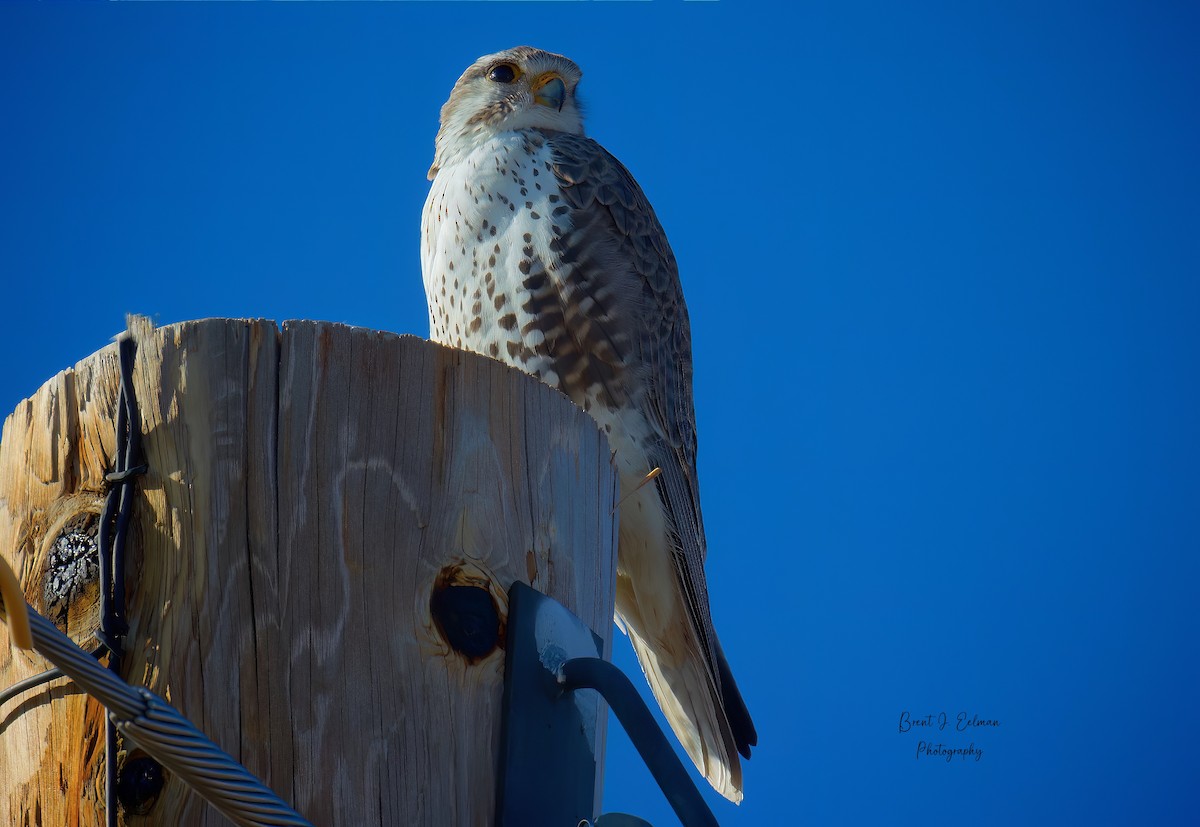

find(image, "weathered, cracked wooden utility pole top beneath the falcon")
[0,319,617,826]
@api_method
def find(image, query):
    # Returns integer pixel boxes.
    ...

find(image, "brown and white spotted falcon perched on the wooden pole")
[421,46,757,802]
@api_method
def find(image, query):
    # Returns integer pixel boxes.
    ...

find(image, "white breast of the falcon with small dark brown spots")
[421,132,568,384]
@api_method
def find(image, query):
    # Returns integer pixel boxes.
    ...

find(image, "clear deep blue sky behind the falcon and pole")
[0,0,1200,827]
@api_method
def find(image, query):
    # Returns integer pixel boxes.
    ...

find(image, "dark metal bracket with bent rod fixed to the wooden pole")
[496,582,716,827]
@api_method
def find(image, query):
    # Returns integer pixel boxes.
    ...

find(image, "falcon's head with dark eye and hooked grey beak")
[430,46,583,181]
